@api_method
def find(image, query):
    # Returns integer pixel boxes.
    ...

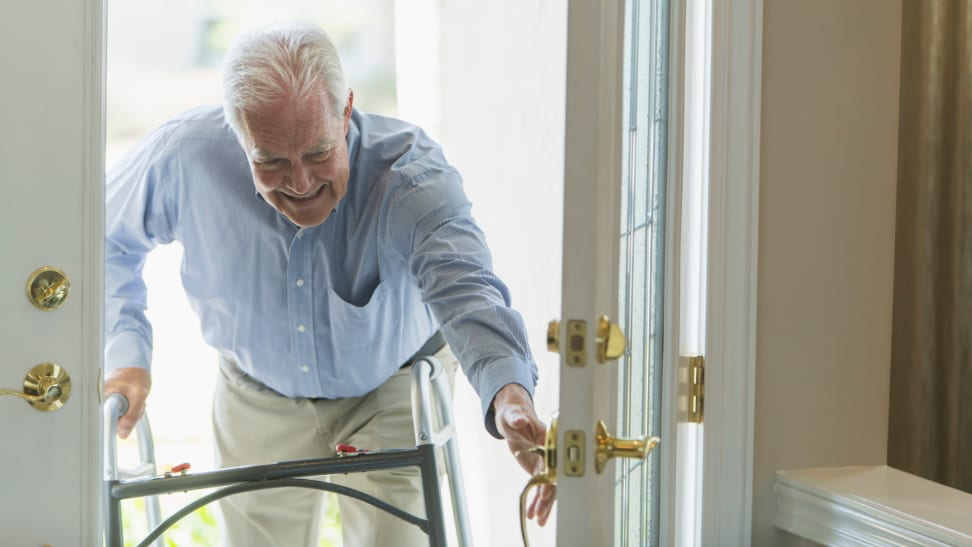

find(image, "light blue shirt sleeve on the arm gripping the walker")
[105,134,174,376]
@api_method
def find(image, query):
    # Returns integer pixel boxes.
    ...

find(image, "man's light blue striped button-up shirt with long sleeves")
[105,107,537,435]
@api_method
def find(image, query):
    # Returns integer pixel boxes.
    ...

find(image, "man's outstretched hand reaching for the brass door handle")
[493,384,557,526]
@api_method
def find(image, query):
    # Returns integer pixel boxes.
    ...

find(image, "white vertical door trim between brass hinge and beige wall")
[701,0,763,545]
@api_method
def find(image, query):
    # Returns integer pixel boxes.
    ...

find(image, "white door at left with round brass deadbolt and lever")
[0,0,104,547]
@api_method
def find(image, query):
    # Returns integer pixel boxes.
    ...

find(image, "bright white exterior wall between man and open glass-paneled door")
[396,0,567,546]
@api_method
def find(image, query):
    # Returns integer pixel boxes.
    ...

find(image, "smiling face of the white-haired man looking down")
[242,94,351,228]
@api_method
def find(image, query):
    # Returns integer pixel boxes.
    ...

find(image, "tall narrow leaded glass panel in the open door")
[615,0,669,546]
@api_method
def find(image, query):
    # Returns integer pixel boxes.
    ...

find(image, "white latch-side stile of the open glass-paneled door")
[557,0,624,547]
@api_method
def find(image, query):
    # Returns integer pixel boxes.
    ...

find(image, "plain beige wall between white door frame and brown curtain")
[753,0,901,546]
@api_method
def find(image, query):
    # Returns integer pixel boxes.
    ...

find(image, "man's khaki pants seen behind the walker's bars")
[213,346,457,547]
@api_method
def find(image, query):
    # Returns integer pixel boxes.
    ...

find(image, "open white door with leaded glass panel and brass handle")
[556,0,669,546]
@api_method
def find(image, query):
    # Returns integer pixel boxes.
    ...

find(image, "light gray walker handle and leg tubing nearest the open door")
[412,356,472,547]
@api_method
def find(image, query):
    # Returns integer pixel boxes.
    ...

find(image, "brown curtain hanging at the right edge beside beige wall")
[888,0,972,492]
